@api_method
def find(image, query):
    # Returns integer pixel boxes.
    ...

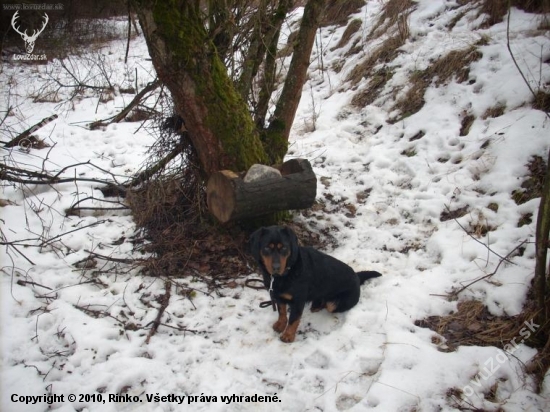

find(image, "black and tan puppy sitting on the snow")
[250,226,381,342]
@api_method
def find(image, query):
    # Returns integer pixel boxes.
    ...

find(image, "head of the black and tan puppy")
[250,226,298,276]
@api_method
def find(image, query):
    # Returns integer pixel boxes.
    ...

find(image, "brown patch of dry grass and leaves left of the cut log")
[127,170,249,290]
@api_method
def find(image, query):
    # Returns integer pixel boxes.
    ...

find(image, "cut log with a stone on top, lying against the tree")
[206,159,317,223]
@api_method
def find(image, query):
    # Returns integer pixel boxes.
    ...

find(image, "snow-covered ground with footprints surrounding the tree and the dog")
[0,0,550,412]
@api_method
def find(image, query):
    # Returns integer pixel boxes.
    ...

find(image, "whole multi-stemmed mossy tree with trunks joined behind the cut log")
[133,0,325,178]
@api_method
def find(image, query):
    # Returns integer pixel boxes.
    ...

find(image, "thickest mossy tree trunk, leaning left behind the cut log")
[135,0,267,177]
